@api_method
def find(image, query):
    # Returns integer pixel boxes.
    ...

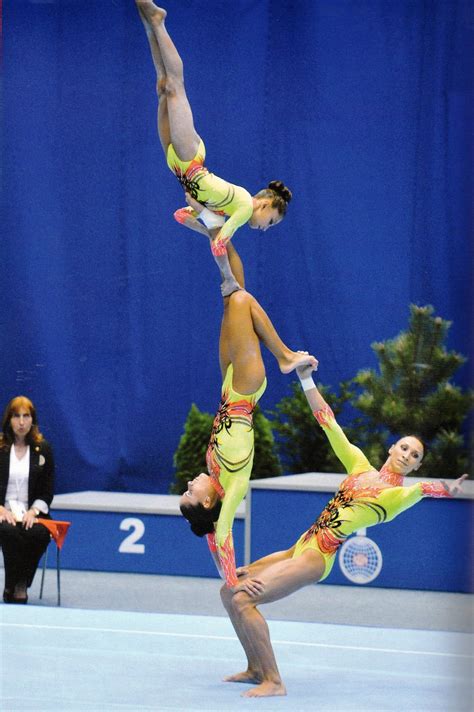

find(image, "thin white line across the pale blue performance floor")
[0,623,473,660]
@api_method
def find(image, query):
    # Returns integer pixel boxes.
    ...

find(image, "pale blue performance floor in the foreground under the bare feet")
[0,605,473,712]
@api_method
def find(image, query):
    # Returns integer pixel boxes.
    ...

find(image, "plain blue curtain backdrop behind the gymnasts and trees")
[0,0,474,492]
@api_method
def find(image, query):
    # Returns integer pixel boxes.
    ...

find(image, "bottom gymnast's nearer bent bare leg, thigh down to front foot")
[223,550,325,697]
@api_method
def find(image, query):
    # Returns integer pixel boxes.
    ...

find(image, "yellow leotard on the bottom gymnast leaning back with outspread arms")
[293,407,451,580]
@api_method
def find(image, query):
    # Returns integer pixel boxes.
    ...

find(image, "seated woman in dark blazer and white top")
[0,396,54,603]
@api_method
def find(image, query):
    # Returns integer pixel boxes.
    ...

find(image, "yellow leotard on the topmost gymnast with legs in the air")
[166,140,253,241]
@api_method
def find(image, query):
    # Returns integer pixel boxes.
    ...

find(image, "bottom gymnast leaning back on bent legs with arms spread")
[221,366,467,697]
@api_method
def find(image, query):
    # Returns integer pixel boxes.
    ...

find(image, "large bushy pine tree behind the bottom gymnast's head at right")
[349,304,473,477]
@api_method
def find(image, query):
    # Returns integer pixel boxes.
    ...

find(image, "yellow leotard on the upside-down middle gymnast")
[206,364,267,586]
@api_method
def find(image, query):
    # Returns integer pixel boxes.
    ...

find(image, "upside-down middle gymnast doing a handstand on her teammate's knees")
[180,243,317,591]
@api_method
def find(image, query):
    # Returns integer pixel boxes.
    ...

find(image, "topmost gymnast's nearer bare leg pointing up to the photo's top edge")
[135,0,200,161]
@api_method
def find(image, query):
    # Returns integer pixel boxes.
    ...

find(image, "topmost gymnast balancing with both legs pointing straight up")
[135,0,291,296]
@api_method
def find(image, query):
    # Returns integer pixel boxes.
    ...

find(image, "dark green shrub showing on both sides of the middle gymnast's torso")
[170,403,282,494]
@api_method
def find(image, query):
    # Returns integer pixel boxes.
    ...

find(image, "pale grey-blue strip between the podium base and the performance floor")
[21,569,474,632]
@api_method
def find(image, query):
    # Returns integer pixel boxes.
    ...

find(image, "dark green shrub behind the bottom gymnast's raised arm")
[270,382,349,473]
